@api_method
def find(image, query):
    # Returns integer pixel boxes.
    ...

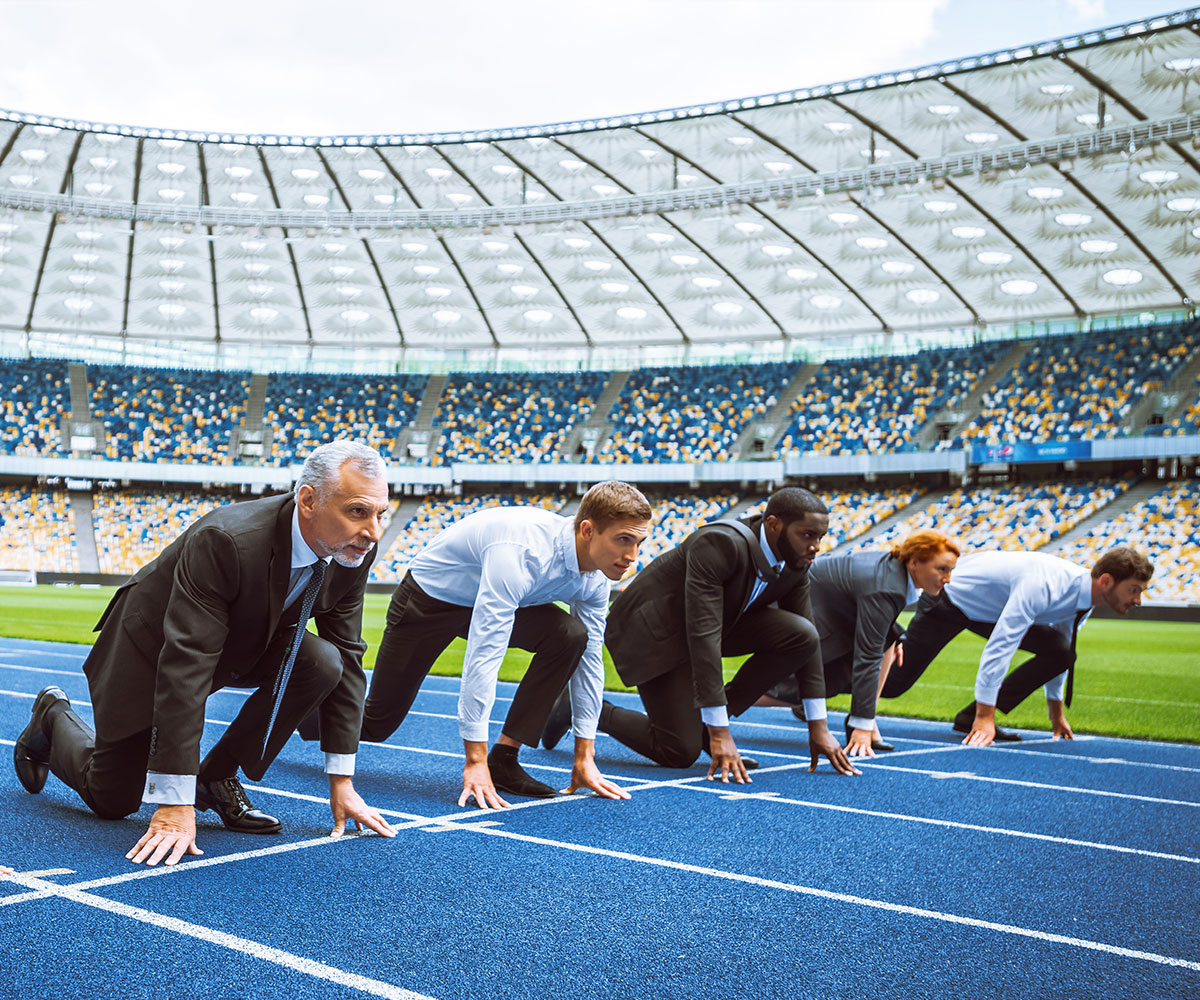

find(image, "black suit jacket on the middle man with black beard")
[605,517,824,708]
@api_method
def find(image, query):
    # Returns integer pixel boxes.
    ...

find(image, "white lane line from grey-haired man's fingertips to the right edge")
[453,830,1200,971]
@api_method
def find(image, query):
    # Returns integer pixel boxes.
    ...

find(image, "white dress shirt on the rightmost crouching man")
[946,552,1092,705]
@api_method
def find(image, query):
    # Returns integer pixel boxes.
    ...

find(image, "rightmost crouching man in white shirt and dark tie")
[882,546,1154,747]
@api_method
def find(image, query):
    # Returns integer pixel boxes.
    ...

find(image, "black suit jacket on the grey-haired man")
[83,495,373,774]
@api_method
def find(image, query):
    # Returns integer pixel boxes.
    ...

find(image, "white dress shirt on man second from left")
[408,507,611,743]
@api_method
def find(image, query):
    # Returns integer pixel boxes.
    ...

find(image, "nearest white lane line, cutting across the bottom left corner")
[0,866,441,1000]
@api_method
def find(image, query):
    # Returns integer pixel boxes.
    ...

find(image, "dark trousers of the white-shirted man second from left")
[362,573,588,747]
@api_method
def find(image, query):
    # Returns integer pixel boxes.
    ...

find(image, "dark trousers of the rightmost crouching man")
[882,593,1075,712]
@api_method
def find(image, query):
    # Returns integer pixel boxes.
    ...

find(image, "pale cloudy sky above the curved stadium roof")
[0,0,1175,134]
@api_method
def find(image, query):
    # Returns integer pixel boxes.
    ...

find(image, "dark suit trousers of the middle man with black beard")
[600,607,821,767]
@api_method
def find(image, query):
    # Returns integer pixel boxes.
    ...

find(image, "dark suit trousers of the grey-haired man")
[48,625,342,820]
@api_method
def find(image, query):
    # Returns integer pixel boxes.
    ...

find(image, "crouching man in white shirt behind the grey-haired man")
[361,481,652,809]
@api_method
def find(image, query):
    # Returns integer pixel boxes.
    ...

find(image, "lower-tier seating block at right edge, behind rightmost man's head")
[1058,479,1200,604]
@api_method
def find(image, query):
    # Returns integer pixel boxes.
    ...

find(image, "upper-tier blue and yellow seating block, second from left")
[88,365,251,465]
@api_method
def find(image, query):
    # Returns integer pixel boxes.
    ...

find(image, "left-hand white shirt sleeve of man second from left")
[458,543,529,743]
